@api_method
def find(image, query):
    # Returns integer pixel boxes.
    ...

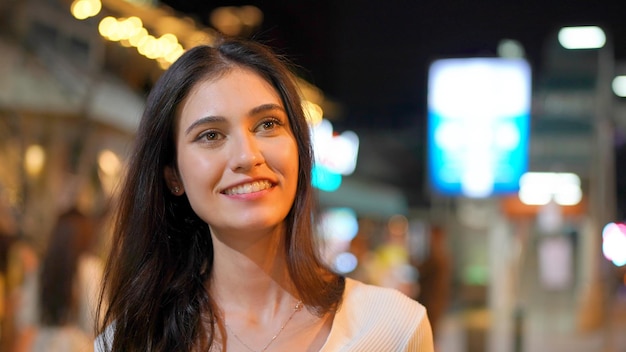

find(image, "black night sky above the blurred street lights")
[158,0,626,208]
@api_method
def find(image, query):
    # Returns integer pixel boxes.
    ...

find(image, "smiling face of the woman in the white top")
[166,68,298,238]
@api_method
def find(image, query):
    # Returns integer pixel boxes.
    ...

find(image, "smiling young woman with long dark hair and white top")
[95,39,433,351]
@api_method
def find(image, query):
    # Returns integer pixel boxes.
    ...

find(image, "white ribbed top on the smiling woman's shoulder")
[320,279,434,352]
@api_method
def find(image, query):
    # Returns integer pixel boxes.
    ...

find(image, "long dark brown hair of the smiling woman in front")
[97,38,345,351]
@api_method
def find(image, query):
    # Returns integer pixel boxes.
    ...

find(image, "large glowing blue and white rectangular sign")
[428,58,532,198]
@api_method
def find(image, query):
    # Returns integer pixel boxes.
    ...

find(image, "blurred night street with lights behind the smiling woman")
[0,0,626,352]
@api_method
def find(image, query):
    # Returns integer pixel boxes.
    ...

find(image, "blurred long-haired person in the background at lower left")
[16,209,100,352]
